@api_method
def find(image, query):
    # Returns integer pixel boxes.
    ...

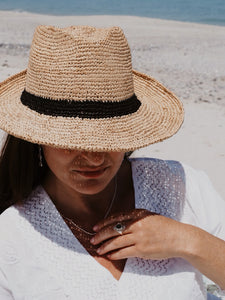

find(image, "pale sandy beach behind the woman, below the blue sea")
[0,11,225,199]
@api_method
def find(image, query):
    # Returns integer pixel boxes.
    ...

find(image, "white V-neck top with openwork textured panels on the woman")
[0,158,225,300]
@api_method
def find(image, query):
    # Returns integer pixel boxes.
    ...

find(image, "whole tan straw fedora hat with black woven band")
[0,26,183,151]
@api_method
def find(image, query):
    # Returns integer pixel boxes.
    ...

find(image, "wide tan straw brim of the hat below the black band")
[0,70,184,151]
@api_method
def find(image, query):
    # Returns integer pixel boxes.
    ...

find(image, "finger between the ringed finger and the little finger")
[97,233,134,255]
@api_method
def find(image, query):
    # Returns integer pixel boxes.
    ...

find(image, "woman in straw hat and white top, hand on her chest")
[0,26,225,300]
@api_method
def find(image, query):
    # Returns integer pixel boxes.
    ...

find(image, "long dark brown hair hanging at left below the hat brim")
[0,135,48,214]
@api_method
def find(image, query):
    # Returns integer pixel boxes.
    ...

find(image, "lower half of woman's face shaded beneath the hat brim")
[42,146,124,195]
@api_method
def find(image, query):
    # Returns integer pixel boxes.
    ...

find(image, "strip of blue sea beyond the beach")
[0,0,225,26]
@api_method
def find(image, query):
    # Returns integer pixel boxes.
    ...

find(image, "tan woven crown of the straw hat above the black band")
[25,26,134,101]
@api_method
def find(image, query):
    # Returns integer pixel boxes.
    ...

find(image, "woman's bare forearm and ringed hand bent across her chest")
[91,209,225,289]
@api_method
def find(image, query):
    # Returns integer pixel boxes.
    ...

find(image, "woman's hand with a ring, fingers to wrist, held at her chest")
[91,209,188,260]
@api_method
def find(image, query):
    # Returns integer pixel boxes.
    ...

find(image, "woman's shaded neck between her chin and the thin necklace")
[43,161,133,230]
